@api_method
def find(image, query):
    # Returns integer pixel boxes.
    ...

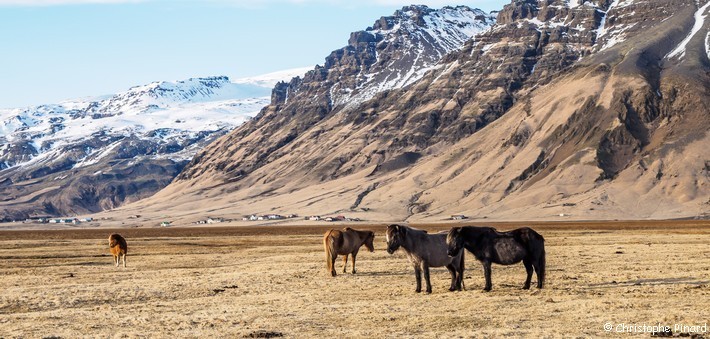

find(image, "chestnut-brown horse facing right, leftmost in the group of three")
[323,227,375,276]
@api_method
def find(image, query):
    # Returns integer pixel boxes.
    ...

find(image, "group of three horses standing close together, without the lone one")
[323,225,545,293]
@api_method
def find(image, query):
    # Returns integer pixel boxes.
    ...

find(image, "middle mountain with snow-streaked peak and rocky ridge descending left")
[180,6,494,180]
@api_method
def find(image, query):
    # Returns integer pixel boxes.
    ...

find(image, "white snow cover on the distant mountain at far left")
[0,70,308,168]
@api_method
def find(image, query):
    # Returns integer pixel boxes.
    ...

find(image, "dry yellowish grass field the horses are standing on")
[0,222,710,338]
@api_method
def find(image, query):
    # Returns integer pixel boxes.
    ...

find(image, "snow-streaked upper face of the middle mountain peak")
[326,6,495,107]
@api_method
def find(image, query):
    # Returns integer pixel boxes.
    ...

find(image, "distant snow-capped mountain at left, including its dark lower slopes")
[0,70,302,220]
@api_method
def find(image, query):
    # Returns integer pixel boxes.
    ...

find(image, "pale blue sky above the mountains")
[0,0,509,108]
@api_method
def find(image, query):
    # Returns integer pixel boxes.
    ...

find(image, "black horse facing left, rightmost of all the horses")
[446,226,545,291]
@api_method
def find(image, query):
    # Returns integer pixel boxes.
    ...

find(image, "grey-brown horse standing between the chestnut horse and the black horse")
[387,225,464,293]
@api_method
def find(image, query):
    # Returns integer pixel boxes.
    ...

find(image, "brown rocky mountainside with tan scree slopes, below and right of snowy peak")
[122,0,710,224]
